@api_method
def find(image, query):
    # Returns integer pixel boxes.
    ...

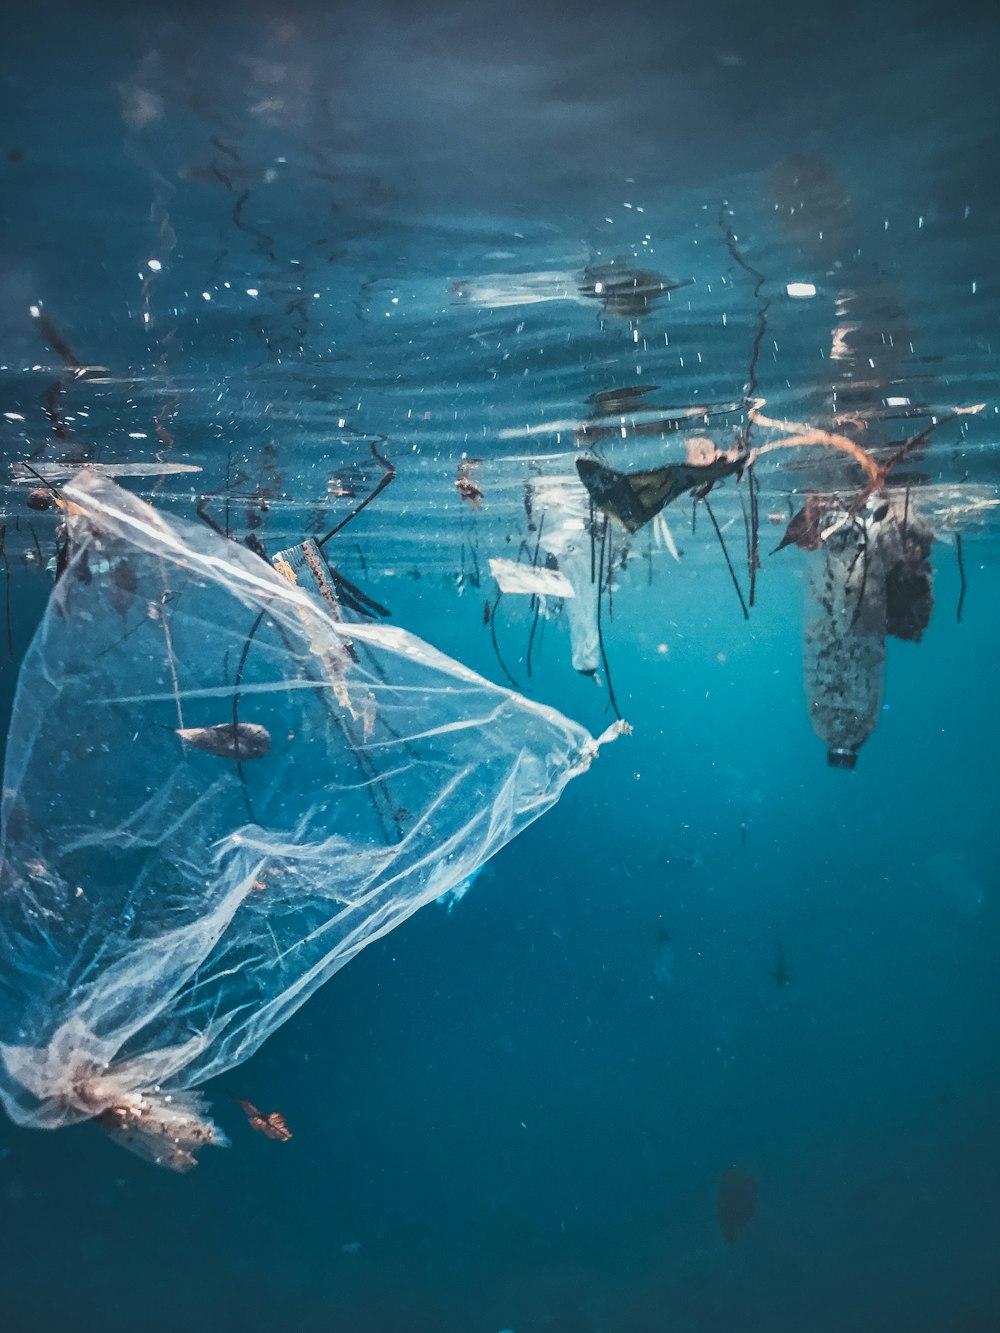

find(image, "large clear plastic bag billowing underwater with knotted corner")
[0,473,624,1170]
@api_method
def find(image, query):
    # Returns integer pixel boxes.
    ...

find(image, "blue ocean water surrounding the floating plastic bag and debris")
[0,3,1000,1333]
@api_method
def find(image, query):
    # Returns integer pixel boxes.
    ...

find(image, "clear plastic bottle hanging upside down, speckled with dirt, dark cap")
[804,509,885,768]
